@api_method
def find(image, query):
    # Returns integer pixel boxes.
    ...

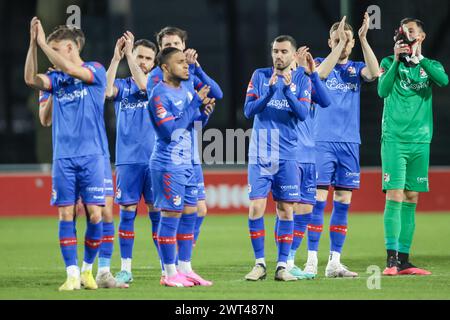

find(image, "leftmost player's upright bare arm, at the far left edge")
[24,17,51,91]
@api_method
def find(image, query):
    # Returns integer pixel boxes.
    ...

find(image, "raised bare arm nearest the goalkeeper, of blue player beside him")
[358,12,380,82]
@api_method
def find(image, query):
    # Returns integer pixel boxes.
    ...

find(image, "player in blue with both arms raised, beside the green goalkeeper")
[304,12,379,278]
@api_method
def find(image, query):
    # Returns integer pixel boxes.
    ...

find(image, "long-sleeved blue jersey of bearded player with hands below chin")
[244,68,311,162]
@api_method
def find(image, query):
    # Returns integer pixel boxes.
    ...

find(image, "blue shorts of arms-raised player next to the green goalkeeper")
[316,142,361,189]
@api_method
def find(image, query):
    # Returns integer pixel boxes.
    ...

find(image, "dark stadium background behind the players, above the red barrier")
[0,0,450,166]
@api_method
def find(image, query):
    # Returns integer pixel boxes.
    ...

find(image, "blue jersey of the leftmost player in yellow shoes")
[47,62,106,160]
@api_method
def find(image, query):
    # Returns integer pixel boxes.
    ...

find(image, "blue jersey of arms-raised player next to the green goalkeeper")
[314,58,366,144]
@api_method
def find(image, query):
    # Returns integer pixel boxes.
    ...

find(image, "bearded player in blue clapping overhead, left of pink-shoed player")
[106,32,160,284]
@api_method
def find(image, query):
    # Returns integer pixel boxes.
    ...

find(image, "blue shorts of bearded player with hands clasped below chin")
[248,160,300,202]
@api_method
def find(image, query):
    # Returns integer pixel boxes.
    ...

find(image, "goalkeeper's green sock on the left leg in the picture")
[384,200,402,251]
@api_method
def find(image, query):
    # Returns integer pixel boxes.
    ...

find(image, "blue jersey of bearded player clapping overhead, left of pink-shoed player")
[114,77,155,165]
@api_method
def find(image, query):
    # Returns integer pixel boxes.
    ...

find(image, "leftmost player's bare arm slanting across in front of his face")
[36,19,92,83]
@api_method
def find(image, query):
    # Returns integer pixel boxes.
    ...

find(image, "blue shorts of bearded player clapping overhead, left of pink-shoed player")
[115,164,153,206]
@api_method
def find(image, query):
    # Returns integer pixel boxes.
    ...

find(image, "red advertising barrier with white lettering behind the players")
[0,169,450,216]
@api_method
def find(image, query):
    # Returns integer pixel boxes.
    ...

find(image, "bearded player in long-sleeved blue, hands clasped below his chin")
[244,36,311,281]
